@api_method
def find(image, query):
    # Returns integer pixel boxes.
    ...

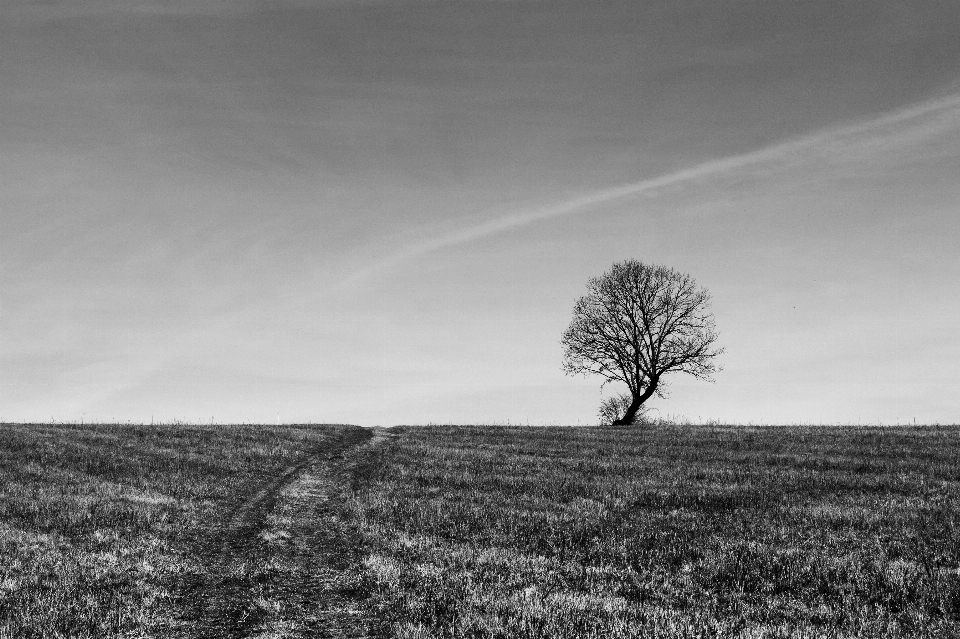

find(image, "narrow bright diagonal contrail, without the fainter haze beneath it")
[328,95,960,292]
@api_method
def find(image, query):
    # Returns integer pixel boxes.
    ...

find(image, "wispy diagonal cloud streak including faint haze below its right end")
[325,94,960,294]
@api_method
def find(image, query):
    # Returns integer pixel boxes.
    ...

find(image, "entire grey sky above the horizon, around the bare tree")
[0,0,960,425]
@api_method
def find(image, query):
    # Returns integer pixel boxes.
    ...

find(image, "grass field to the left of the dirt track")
[0,424,361,639]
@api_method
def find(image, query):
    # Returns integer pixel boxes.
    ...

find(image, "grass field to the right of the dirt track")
[354,426,960,638]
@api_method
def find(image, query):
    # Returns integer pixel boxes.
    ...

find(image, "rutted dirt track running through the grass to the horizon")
[167,429,389,639]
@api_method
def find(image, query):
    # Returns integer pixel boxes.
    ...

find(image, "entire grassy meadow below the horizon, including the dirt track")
[0,424,960,639]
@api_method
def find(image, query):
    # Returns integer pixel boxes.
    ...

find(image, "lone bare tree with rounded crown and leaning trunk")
[561,260,723,424]
